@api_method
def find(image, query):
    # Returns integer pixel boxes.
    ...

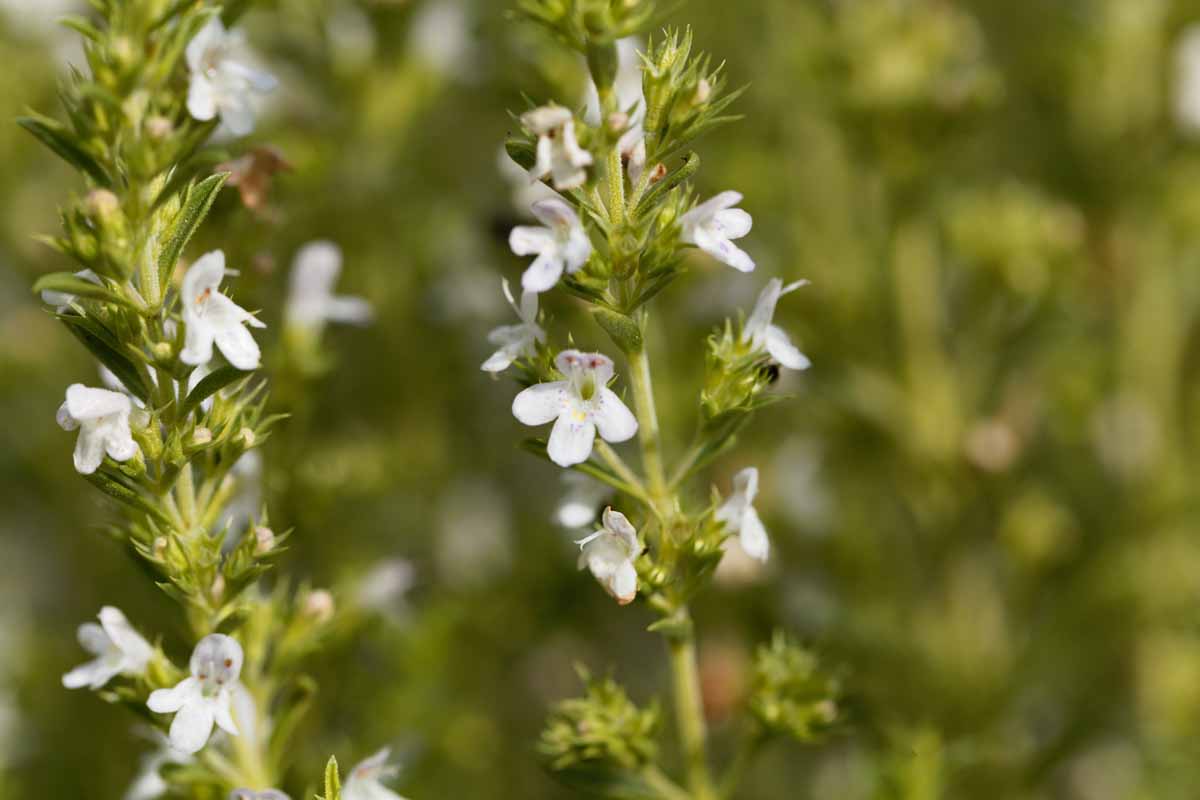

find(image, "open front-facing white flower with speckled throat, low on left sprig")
[146,633,242,753]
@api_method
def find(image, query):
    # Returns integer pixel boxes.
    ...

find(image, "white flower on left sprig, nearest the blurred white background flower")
[179,249,266,369]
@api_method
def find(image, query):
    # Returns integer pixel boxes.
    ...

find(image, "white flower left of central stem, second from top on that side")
[509,198,592,291]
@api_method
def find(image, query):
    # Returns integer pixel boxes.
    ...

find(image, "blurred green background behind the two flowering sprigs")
[7,0,1200,800]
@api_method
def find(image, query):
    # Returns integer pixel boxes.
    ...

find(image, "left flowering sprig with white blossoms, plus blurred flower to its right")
[20,0,398,798]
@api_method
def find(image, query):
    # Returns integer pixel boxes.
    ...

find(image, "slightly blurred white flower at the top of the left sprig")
[187,18,277,136]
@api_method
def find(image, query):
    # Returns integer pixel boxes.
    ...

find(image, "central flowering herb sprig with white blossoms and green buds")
[501,0,838,800]
